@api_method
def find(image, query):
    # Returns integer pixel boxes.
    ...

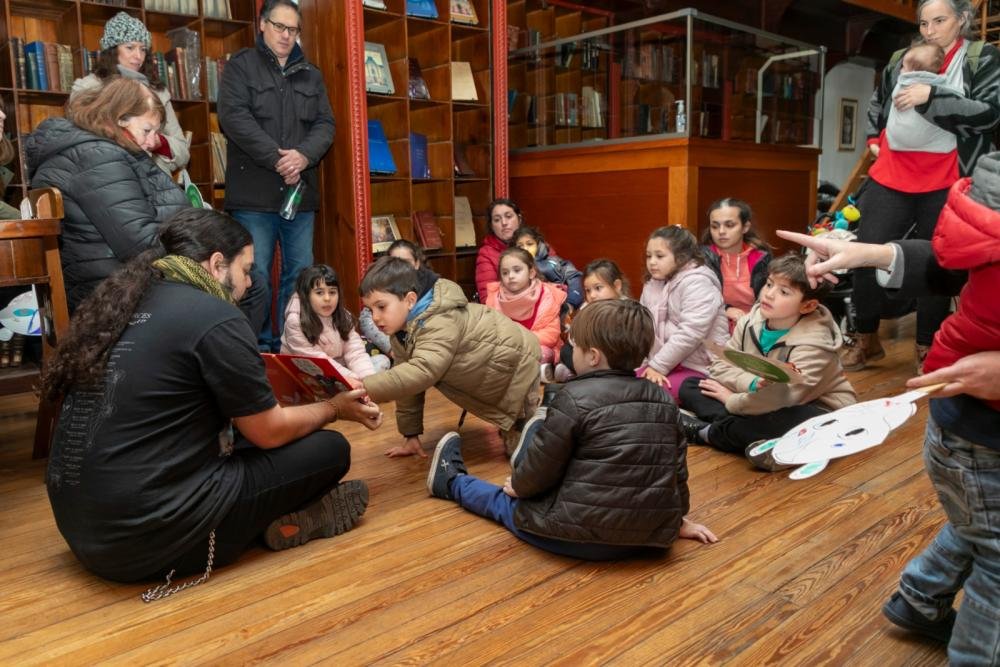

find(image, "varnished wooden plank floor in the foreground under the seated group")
[0,318,945,667]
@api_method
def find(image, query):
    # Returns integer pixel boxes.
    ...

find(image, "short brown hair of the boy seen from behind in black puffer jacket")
[572,299,655,371]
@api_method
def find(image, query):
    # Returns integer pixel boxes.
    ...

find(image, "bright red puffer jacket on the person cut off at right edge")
[924,178,1000,410]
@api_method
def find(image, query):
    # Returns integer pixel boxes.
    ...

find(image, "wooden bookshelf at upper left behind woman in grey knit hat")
[0,0,256,206]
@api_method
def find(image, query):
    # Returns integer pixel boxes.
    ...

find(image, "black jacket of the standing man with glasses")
[218,35,334,211]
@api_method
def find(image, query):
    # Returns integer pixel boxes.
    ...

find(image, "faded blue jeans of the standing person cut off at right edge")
[899,418,1000,665]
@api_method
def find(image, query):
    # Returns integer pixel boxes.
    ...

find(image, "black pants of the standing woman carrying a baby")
[851,179,951,345]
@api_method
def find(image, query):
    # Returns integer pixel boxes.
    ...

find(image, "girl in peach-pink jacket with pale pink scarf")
[486,248,566,380]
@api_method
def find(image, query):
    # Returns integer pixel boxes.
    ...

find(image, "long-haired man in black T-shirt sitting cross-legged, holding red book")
[41,208,381,599]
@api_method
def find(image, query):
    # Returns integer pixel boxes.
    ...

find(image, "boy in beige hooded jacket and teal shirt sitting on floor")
[680,255,857,469]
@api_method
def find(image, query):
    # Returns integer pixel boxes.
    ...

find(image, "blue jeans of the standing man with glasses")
[230,211,316,352]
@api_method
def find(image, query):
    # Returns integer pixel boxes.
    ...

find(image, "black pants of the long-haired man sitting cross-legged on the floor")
[161,431,351,577]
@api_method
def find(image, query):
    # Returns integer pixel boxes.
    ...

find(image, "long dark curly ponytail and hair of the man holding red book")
[39,208,253,401]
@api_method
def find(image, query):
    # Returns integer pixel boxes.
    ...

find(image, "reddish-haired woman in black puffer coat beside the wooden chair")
[25,79,191,311]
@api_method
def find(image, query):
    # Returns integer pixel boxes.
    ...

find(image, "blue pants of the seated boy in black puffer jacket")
[450,475,653,560]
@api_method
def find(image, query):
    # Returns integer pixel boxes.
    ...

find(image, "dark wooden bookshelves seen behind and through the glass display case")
[507,0,820,150]
